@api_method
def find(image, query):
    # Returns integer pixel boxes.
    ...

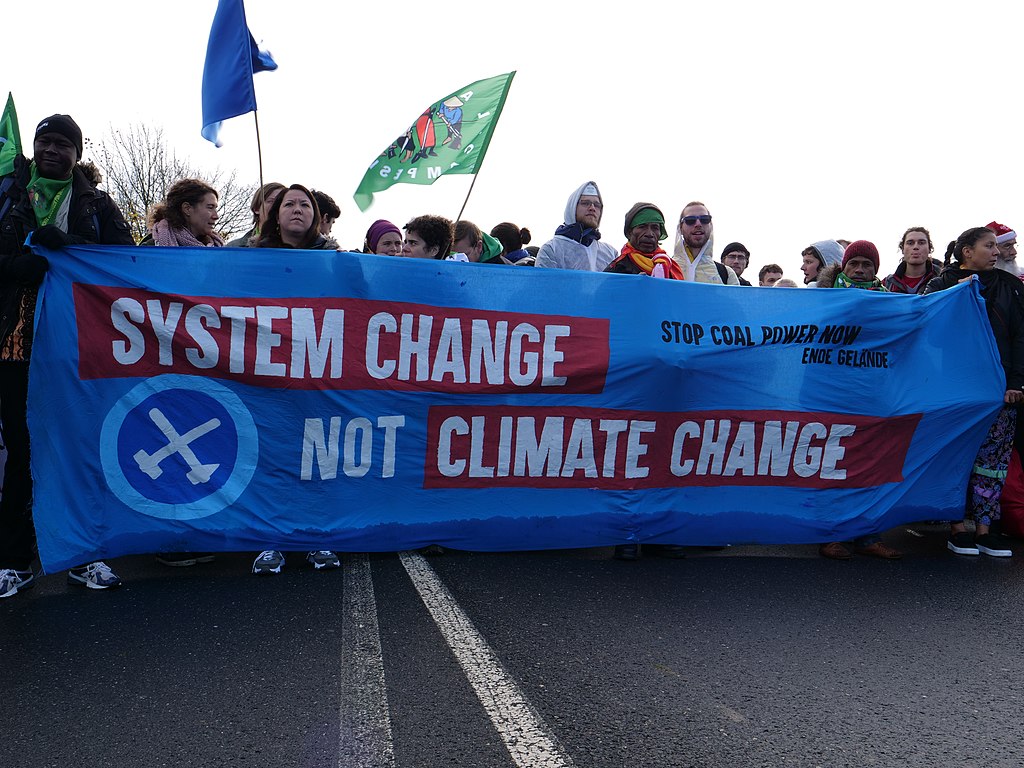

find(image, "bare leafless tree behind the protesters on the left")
[85,123,256,243]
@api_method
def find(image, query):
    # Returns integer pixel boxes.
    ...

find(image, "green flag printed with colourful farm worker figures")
[353,72,515,211]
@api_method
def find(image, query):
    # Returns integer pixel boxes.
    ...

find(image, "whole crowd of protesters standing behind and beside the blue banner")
[0,115,1024,598]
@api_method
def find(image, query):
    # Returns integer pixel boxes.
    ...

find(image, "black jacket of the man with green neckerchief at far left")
[0,155,135,356]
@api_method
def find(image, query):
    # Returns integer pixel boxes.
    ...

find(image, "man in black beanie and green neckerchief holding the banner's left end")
[0,115,134,598]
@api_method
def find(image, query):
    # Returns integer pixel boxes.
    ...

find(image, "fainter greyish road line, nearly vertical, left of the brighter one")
[338,554,394,768]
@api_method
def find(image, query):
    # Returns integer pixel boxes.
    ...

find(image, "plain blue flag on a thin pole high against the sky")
[203,0,278,146]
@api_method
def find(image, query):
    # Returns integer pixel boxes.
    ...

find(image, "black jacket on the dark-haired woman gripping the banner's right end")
[925,265,1024,389]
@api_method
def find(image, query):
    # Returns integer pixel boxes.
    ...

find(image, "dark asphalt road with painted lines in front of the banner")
[0,526,1024,768]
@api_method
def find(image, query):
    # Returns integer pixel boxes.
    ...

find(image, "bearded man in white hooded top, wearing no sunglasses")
[536,181,618,272]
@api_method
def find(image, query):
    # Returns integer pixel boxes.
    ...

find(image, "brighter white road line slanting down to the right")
[399,552,574,768]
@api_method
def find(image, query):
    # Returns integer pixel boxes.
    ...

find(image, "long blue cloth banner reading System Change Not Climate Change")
[29,247,1004,570]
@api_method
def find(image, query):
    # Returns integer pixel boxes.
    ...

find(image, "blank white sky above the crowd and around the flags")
[0,0,1024,282]
